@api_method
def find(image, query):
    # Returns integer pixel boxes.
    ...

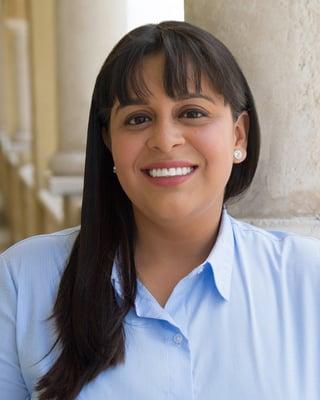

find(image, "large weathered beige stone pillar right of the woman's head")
[185,0,320,236]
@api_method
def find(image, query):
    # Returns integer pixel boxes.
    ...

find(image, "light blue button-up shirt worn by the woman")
[0,210,320,400]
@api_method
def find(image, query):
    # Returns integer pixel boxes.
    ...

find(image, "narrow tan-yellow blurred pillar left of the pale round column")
[27,0,58,189]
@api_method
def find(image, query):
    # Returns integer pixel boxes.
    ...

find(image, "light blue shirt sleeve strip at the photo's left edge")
[0,255,30,400]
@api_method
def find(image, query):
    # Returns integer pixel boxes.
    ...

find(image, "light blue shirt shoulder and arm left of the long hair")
[0,228,79,398]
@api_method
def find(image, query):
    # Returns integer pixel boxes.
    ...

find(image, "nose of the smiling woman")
[147,121,185,153]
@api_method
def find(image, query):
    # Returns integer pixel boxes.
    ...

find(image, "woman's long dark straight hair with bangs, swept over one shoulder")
[36,21,260,400]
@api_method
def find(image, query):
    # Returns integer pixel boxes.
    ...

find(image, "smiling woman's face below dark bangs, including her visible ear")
[109,54,248,225]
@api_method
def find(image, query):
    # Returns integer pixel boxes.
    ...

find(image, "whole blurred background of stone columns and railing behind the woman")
[0,0,320,251]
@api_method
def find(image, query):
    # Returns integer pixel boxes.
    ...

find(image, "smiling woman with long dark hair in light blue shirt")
[0,22,320,400]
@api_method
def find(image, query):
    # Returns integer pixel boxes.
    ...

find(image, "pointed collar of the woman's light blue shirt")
[111,208,235,301]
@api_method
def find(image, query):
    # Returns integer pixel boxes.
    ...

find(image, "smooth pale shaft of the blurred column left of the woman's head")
[56,0,126,155]
